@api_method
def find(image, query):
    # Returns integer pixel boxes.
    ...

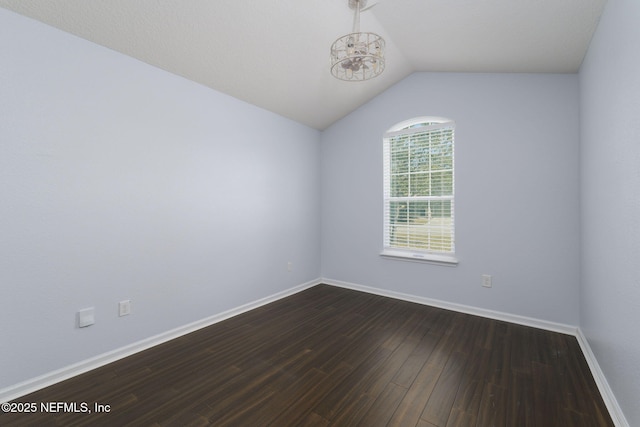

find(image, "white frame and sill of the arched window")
[380,116,458,266]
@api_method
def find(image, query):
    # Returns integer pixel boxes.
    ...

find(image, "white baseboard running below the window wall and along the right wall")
[321,278,629,427]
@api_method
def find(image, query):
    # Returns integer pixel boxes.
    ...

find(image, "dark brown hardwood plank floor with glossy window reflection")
[0,285,613,427]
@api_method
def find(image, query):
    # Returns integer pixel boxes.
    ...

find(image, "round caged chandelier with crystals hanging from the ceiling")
[331,0,385,81]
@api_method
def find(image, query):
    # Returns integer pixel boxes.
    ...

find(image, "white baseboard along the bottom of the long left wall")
[0,279,321,403]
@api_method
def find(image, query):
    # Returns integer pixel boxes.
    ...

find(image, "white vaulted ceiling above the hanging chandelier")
[0,0,606,129]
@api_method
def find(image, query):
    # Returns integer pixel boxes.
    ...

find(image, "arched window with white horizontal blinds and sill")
[383,117,455,262]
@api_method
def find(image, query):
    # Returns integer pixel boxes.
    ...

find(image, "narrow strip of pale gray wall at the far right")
[580,0,640,426]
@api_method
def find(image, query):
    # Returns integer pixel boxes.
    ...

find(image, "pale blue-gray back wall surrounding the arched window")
[321,73,579,325]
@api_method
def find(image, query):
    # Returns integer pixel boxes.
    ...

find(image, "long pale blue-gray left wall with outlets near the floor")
[0,9,320,388]
